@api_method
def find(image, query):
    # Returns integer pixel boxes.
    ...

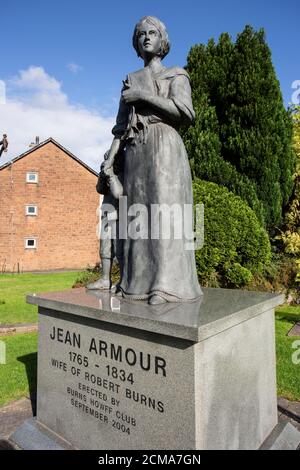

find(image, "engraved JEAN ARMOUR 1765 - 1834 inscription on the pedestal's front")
[48,326,168,435]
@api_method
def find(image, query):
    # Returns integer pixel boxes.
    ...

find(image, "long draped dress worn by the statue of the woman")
[112,67,202,302]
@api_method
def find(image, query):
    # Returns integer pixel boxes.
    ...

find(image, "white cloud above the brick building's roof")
[0,67,115,170]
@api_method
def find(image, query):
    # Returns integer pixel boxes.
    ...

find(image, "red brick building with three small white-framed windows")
[0,138,99,273]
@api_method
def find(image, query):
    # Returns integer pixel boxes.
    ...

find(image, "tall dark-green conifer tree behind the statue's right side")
[184,26,295,229]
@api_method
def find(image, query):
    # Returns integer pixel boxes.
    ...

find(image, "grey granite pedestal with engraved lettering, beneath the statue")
[9,289,300,450]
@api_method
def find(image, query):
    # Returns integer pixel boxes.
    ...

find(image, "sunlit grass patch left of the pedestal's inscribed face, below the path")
[0,333,37,406]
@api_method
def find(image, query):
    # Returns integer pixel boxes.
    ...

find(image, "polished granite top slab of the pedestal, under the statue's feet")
[27,288,284,342]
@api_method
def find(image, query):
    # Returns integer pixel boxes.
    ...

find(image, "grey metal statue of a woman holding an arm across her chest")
[105,16,202,305]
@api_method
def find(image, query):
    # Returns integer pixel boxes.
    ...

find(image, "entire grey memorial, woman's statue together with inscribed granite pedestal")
[11,17,300,450]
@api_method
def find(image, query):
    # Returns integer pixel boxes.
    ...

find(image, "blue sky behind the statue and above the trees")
[0,0,300,168]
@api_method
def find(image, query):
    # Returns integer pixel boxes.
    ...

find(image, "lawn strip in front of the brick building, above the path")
[0,272,79,324]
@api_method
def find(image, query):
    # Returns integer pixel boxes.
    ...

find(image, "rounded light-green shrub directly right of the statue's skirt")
[193,180,271,287]
